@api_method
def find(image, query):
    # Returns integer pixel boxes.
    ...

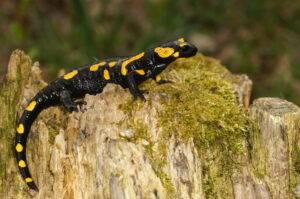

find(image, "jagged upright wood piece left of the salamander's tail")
[0,50,45,198]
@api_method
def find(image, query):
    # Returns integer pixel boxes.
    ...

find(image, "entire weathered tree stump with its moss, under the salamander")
[0,50,300,199]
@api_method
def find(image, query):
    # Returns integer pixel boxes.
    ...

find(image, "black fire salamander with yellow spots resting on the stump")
[15,38,197,191]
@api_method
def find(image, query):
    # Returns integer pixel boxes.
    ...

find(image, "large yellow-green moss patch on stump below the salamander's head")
[119,54,255,197]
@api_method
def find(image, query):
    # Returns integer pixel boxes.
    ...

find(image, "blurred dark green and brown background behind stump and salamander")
[0,0,300,105]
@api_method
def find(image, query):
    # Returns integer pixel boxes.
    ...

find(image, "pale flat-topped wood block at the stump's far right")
[250,98,300,199]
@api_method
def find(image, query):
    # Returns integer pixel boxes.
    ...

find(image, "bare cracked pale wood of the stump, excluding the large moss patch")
[0,50,300,199]
